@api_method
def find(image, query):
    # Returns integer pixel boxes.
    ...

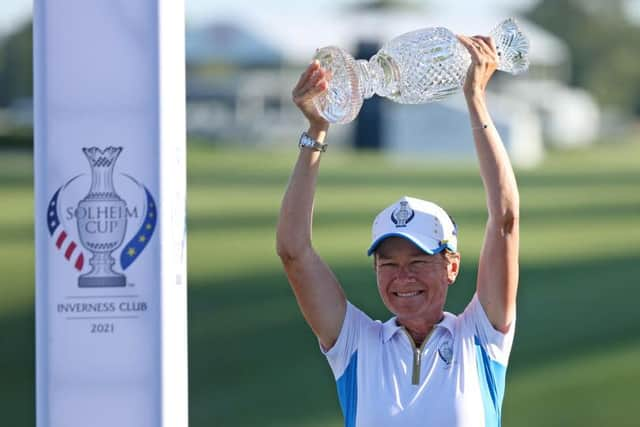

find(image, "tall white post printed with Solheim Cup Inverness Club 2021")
[34,0,188,427]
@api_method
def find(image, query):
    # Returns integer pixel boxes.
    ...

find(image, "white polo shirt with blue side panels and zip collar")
[323,295,515,427]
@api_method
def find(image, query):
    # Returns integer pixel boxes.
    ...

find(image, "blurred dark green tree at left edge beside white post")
[0,21,33,106]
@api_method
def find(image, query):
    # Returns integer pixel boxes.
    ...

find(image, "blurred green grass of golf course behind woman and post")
[0,140,640,427]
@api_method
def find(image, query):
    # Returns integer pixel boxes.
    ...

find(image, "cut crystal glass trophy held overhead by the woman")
[314,18,529,123]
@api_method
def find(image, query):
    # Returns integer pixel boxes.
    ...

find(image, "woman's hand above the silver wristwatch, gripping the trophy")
[291,60,329,131]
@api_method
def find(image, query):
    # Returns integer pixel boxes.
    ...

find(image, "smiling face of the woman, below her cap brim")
[375,237,459,323]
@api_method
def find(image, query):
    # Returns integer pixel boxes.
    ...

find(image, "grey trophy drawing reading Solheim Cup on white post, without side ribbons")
[76,147,127,287]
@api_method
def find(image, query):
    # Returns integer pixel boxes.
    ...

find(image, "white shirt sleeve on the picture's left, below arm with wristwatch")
[318,301,374,380]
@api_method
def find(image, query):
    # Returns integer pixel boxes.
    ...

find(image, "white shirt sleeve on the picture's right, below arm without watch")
[460,294,516,366]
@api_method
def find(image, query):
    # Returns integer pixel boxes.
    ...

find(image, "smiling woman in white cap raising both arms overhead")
[277,31,519,427]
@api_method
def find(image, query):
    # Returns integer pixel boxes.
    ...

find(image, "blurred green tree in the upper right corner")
[527,0,640,116]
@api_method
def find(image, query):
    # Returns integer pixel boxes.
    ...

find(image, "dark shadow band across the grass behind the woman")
[0,256,640,427]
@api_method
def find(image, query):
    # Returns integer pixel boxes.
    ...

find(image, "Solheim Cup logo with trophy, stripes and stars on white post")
[47,147,157,288]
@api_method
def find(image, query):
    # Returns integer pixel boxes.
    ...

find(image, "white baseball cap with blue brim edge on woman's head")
[367,196,458,255]
